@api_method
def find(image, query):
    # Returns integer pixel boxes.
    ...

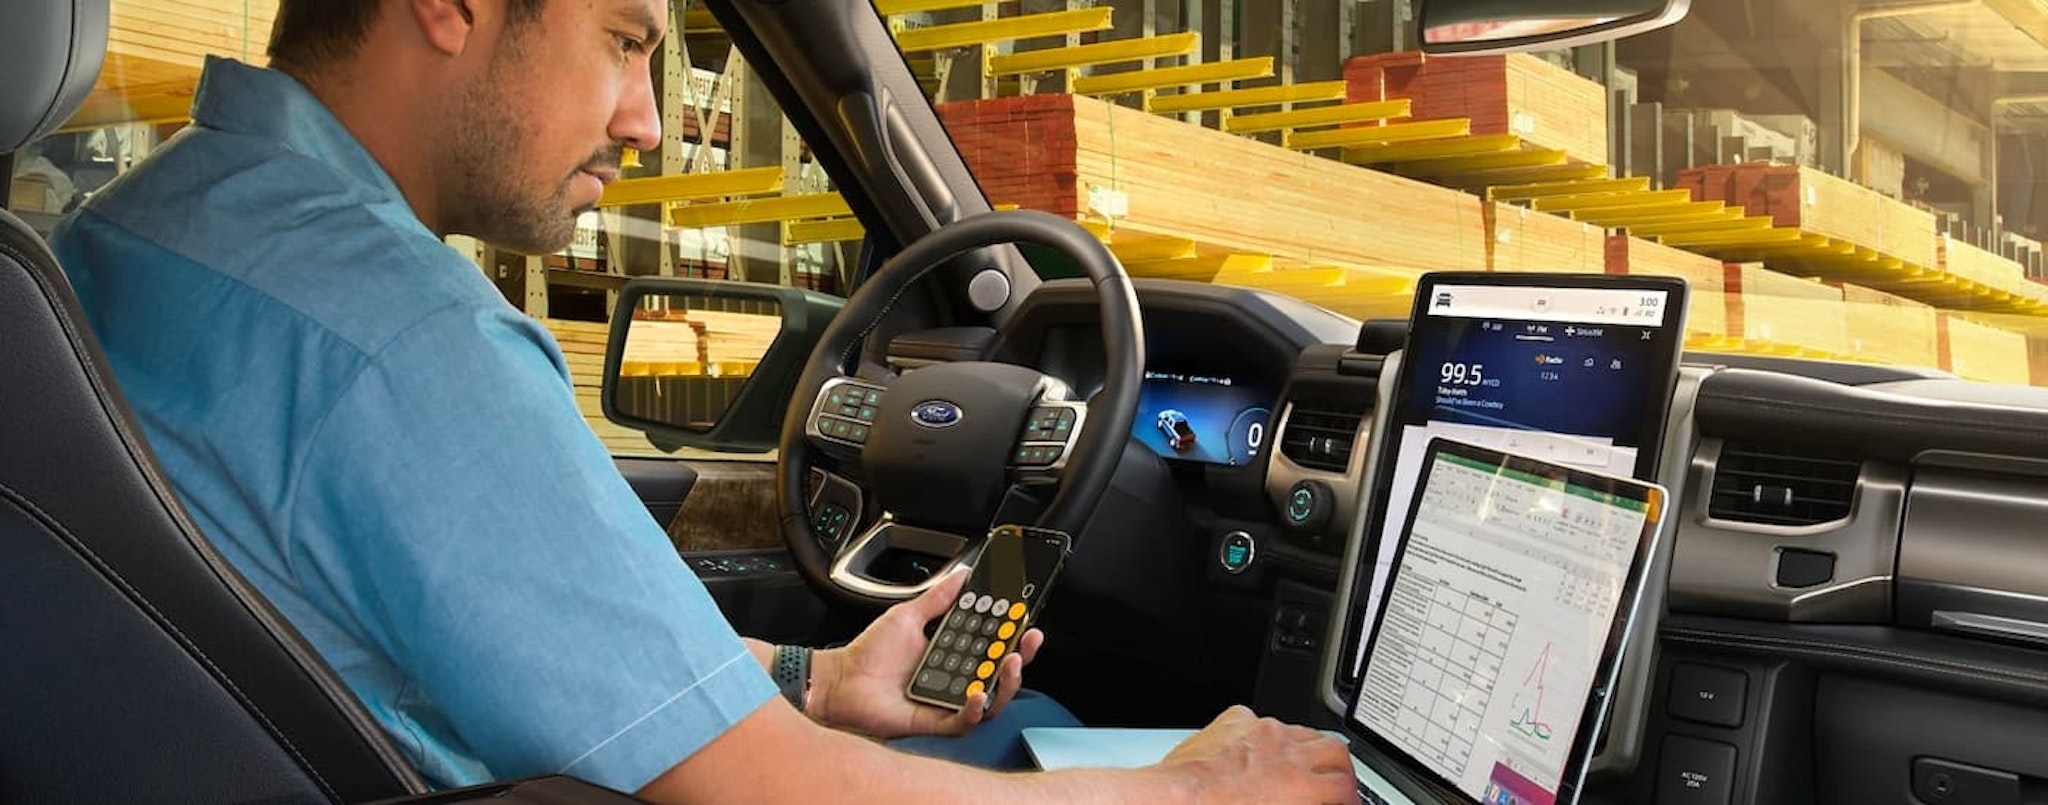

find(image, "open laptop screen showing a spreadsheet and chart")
[1352,438,1663,805]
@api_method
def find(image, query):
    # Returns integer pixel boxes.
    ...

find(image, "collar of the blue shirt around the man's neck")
[193,55,401,201]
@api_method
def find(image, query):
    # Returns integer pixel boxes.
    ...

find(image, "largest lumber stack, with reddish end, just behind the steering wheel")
[938,94,1487,270]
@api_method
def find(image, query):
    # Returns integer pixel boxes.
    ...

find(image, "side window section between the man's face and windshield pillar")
[453,23,864,461]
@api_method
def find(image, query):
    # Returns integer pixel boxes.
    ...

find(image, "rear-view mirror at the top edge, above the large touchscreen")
[1415,0,1692,55]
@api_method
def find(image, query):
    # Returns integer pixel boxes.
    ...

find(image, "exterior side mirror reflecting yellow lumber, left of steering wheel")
[602,277,844,453]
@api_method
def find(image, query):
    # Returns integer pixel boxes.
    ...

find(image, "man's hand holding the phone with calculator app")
[809,569,1044,737]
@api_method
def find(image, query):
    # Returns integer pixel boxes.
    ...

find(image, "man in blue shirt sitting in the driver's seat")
[55,0,1352,803]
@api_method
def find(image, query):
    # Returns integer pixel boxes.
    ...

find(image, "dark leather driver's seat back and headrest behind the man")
[0,0,424,803]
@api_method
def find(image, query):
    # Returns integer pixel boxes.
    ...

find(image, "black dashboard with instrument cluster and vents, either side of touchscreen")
[1001,281,2048,805]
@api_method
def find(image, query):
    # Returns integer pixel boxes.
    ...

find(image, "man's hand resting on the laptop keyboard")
[1155,707,1358,803]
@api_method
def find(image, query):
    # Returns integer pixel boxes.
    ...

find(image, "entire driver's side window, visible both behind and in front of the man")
[8,0,862,461]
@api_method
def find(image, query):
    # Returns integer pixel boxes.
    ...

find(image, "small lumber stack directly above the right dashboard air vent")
[1722,262,1849,356]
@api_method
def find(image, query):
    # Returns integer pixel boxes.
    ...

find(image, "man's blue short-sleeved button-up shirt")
[55,59,774,791]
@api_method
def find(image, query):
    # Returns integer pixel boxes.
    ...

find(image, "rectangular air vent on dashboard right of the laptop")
[1706,442,1864,526]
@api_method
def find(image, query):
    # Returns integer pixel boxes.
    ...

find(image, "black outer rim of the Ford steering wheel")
[776,211,1145,608]
